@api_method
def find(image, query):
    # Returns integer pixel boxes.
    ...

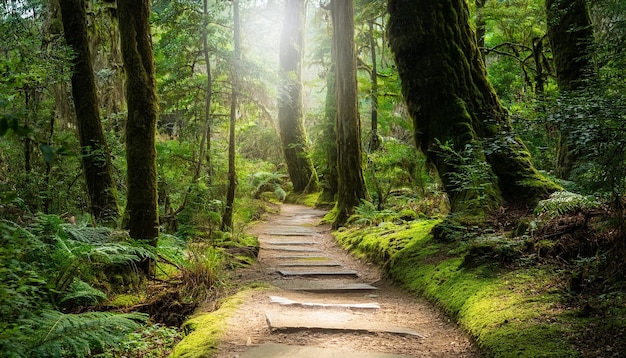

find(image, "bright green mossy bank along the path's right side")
[335,220,626,357]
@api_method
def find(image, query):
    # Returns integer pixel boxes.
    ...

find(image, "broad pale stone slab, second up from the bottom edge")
[265,310,424,338]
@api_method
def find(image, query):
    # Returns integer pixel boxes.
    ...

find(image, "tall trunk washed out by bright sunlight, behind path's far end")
[278,0,319,195]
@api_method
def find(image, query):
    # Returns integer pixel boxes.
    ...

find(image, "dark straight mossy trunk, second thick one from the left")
[117,0,159,275]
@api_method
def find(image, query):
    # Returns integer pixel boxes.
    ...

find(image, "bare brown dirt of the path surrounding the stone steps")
[216,204,481,358]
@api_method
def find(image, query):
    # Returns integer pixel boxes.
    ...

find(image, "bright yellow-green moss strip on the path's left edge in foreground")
[170,286,266,358]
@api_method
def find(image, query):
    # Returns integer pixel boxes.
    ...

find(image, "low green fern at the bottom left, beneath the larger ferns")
[26,310,147,357]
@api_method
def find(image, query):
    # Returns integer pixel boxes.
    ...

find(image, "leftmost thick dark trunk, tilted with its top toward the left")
[60,0,119,224]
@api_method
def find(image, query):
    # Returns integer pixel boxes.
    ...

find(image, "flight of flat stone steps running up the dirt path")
[238,208,426,358]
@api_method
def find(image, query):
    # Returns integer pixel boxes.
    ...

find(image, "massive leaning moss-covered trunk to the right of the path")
[388,0,556,215]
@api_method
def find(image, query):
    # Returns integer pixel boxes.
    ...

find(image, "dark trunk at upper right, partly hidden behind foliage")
[546,0,593,178]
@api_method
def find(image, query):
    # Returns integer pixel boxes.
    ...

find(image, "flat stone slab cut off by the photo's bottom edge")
[239,343,410,358]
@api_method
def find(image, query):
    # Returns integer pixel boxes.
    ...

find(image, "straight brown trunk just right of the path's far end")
[331,0,367,228]
